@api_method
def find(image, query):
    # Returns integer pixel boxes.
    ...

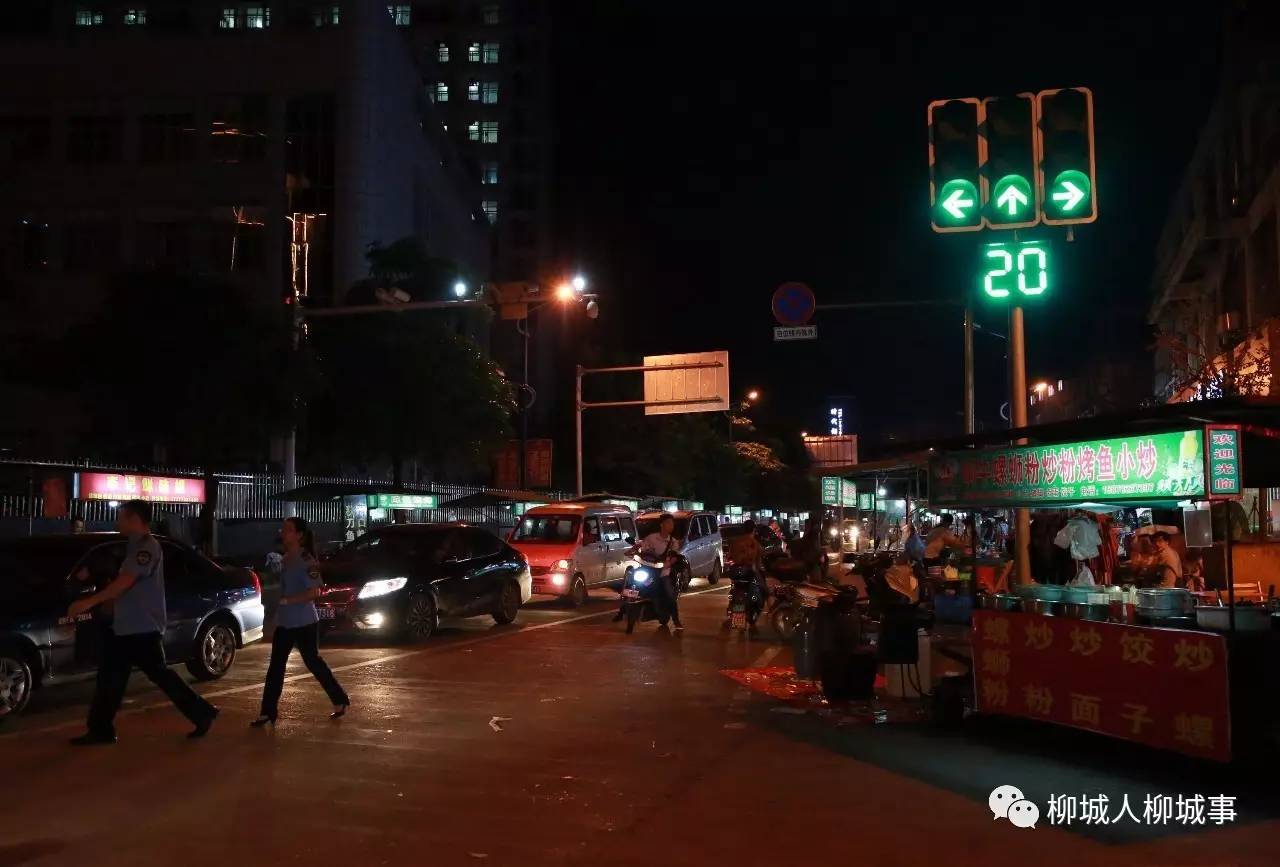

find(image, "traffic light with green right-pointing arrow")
[1036,87,1098,225]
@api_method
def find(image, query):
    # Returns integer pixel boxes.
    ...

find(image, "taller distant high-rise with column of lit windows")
[387,0,553,280]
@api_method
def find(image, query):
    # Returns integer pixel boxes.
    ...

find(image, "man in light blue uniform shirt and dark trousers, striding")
[67,499,218,747]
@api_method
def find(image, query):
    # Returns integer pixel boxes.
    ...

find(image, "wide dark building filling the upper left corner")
[0,0,490,321]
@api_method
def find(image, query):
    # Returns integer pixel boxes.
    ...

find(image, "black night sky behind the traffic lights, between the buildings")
[554,0,1221,439]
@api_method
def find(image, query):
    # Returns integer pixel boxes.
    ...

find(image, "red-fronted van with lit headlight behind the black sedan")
[507,503,636,607]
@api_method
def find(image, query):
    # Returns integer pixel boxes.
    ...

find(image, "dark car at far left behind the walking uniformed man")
[0,533,264,720]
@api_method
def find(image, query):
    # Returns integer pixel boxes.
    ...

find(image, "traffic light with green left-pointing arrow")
[929,97,982,232]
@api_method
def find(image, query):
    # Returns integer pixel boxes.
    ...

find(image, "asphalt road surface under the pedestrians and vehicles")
[0,587,1280,867]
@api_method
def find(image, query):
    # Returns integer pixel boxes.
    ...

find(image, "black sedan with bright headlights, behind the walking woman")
[316,524,531,639]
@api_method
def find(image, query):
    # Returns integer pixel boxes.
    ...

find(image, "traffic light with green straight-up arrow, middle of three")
[982,93,1039,229]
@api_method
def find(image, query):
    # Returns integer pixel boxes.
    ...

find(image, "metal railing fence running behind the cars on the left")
[0,460,572,526]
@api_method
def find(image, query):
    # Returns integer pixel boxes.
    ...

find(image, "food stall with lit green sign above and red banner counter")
[929,414,1280,761]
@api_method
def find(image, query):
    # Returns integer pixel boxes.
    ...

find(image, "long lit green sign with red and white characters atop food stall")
[929,429,1208,506]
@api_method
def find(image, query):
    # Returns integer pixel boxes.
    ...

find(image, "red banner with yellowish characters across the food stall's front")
[973,611,1231,762]
